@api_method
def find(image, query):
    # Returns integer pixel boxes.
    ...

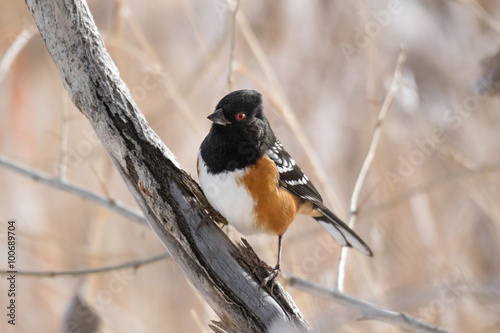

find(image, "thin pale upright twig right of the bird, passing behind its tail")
[336,48,406,292]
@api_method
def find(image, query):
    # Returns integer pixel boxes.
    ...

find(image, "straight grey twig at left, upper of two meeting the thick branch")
[0,156,146,224]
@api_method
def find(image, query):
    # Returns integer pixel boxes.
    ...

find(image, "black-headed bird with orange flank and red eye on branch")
[196,90,373,290]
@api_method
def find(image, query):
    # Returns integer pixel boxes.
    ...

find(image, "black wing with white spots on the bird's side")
[266,139,323,204]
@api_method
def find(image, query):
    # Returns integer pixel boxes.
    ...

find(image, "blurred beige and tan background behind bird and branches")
[0,0,500,333]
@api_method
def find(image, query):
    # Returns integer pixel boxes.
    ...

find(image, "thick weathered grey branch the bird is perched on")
[26,0,309,332]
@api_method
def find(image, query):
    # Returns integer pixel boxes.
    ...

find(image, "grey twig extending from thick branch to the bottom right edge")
[284,276,449,333]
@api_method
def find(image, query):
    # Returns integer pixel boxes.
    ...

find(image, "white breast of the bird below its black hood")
[198,152,262,235]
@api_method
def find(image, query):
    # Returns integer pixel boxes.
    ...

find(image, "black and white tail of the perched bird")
[314,206,373,257]
